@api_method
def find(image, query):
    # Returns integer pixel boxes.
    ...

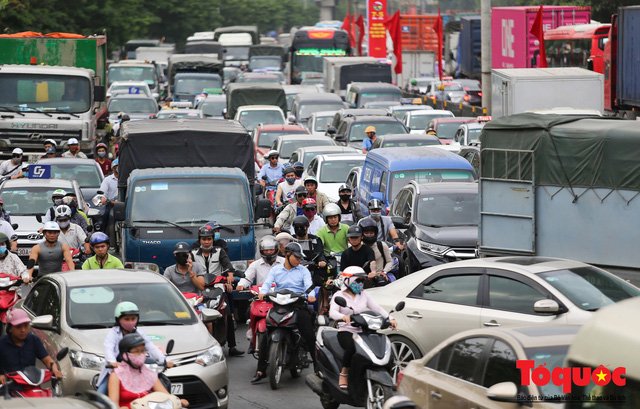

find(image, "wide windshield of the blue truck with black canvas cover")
[131,177,250,226]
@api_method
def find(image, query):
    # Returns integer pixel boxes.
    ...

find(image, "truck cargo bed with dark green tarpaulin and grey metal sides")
[478,113,640,270]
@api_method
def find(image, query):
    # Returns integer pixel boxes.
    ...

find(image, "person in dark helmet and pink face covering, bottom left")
[109,334,189,408]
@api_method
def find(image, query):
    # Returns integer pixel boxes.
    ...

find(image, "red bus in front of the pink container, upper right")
[544,23,611,74]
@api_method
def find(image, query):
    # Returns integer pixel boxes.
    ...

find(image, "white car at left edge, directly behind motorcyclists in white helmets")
[0,178,89,265]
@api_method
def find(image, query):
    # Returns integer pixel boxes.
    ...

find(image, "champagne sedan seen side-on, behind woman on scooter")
[367,255,640,370]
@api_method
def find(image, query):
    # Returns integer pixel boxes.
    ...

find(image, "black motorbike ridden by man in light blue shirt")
[266,290,313,389]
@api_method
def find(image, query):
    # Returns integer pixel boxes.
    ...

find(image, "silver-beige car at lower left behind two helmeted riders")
[16,269,229,408]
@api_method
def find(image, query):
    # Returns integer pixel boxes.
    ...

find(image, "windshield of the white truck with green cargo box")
[0,74,92,113]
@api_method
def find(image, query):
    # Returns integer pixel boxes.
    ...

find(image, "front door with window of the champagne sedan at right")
[481,268,567,327]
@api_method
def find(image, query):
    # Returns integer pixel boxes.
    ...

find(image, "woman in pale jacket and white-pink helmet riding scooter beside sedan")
[329,266,398,389]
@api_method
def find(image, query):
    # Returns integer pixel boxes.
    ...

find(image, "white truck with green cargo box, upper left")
[0,32,107,160]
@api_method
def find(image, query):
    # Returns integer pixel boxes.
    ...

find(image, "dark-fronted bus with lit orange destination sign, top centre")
[288,27,352,84]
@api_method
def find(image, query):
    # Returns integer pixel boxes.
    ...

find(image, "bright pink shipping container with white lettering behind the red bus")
[491,5,591,68]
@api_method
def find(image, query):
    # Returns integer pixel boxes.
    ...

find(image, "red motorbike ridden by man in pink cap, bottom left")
[3,347,69,399]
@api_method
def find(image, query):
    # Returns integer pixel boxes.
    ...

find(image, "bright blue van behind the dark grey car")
[357,147,477,215]
